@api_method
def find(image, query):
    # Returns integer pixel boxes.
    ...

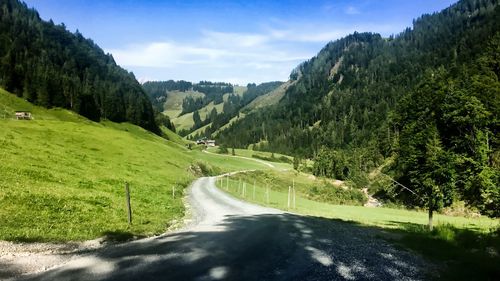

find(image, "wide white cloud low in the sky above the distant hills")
[107,24,400,84]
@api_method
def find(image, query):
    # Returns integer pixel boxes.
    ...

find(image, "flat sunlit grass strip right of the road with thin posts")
[217,168,499,231]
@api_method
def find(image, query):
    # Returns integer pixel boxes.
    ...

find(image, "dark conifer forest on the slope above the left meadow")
[0,0,160,133]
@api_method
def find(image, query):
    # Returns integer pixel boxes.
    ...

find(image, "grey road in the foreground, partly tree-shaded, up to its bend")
[18,178,427,281]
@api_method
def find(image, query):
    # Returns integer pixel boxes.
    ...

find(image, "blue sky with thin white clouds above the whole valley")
[25,0,456,85]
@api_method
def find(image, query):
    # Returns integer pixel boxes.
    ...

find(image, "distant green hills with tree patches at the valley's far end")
[143,80,283,138]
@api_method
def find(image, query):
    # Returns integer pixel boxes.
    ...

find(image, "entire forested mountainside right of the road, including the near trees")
[219,0,500,216]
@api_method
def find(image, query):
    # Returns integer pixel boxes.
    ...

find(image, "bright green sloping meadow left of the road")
[0,90,274,241]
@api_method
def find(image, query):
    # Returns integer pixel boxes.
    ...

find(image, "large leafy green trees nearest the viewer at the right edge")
[391,37,500,217]
